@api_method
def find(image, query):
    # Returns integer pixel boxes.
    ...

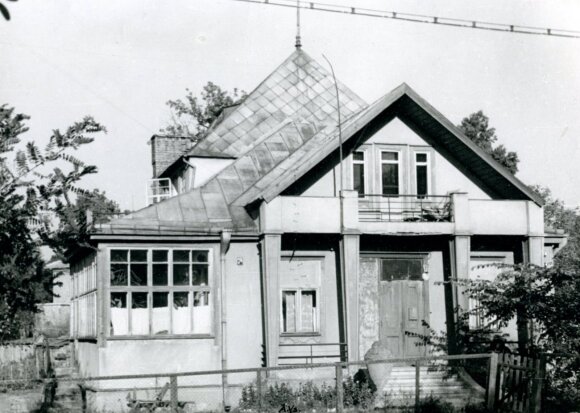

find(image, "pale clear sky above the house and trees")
[0,0,580,209]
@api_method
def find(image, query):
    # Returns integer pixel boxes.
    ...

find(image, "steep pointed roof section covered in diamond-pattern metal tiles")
[189,48,367,157]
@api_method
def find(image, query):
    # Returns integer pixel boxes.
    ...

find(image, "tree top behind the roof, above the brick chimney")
[161,82,246,140]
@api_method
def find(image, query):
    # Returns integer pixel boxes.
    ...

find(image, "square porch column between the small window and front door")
[341,234,360,361]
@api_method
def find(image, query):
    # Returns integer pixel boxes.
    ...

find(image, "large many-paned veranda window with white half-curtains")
[110,249,211,336]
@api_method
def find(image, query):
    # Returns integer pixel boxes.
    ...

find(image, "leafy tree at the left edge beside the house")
[0,105,104,340]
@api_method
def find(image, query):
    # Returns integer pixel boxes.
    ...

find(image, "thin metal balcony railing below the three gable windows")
[359,194,453,222]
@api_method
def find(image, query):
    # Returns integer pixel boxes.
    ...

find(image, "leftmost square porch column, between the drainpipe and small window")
[262,233,282,367]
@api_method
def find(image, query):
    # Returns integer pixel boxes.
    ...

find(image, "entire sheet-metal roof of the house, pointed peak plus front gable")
[100,51,543,235]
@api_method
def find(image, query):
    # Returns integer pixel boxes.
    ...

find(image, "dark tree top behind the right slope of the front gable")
[458,110,520,174]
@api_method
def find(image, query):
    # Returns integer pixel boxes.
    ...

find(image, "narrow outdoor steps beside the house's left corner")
[48,340,83,413]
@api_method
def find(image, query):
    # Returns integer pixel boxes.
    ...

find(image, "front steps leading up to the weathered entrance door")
[377,366,485,407]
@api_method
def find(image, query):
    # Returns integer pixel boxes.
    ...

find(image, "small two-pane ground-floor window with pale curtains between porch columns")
[282,289,319,333]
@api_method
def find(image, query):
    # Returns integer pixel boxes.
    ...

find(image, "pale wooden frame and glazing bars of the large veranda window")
[104,245,216,340]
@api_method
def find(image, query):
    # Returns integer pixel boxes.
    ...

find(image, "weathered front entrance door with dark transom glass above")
[379,256,429,357]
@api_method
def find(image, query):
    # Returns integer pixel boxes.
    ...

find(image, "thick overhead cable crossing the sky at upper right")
[231,0,580,39]
